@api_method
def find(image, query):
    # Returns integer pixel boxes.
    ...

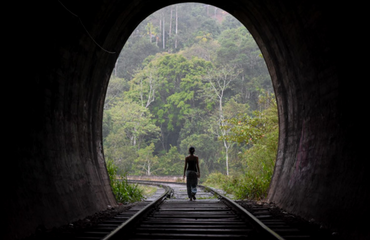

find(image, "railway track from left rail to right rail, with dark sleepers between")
[100,184,283,240]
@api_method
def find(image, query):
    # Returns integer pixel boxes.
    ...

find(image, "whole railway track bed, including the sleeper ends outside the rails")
[63,181,330,240]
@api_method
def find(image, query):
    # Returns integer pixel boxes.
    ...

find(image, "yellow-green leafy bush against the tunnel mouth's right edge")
[217,92,279,198]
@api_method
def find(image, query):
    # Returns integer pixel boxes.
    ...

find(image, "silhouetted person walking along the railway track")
[183,147,200,201]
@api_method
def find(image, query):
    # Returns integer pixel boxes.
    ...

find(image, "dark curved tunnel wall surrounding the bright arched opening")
[7,0,370,239]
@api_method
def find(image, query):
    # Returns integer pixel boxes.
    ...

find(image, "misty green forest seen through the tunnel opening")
[103,3,278,198]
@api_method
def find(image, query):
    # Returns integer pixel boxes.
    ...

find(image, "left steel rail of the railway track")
[103,183,173,240]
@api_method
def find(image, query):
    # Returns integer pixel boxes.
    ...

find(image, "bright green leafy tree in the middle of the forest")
[135,54,210,151]
